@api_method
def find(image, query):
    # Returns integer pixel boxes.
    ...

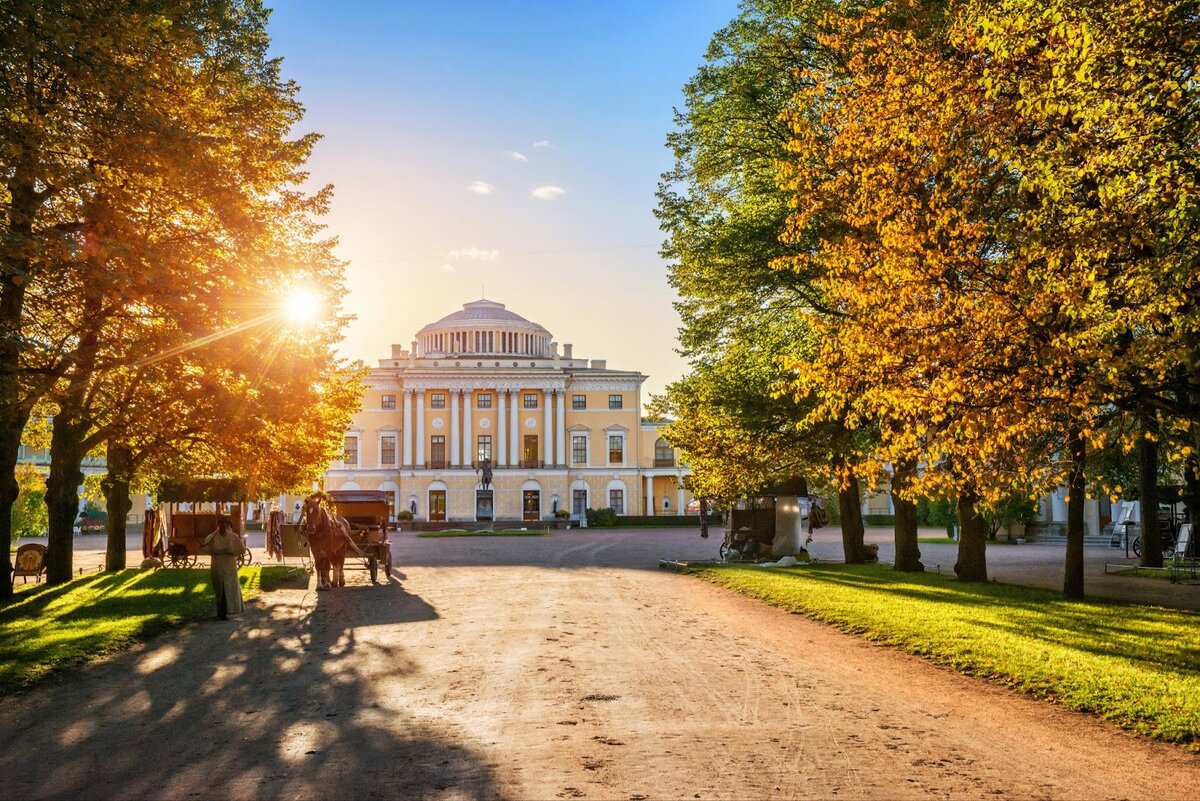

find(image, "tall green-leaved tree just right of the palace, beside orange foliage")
[656,0,883,561]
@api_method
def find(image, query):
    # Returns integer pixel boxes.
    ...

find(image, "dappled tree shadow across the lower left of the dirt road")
[0,583,500,799]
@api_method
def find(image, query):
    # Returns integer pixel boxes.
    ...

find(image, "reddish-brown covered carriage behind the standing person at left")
[158,478,253,567]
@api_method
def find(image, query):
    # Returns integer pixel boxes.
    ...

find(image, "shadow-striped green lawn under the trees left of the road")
[0,567,297,697]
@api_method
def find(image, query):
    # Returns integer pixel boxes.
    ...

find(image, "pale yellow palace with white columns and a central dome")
[324,300,691,523]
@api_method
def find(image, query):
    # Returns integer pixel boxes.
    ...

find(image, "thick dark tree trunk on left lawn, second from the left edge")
[46,403,88,584]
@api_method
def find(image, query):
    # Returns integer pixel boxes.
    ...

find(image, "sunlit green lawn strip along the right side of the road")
[691,564,1200,749]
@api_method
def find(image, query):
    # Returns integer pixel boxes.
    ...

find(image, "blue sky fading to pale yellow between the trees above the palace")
[270,0,737,392]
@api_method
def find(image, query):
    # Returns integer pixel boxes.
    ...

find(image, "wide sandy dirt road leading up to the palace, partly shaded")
[0,531,1200,799]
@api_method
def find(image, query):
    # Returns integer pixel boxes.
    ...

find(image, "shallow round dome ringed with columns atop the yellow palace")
[416,300,552,356]
